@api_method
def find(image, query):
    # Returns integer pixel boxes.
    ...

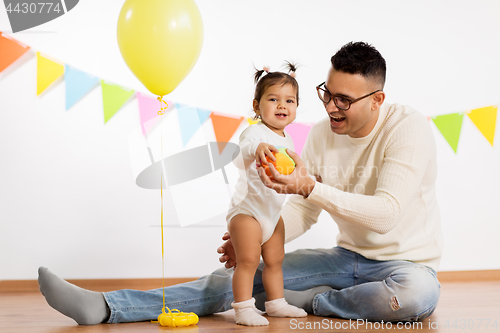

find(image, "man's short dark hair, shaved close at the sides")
[331,42,386,87]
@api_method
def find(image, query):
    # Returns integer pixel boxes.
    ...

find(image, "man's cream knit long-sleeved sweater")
[281,104,442,270]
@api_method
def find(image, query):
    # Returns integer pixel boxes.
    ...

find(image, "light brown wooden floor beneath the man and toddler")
[0,281,500,333]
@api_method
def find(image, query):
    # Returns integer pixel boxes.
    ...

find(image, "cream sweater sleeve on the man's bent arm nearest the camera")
[306,115,435,234]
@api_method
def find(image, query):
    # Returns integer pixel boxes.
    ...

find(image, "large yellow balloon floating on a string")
[117,0,203,96]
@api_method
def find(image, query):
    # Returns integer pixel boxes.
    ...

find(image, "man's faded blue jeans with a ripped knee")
[103,247,440,323]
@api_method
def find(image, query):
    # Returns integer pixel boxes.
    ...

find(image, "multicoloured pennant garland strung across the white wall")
[0,32,498,155]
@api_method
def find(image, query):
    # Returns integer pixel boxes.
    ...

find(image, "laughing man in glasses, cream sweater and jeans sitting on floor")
[39,42,442,324]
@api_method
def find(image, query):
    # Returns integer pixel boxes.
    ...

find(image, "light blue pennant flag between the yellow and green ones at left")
[64,65,99,110]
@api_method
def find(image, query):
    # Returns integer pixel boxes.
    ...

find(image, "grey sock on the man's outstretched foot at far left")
[38,267,110,325]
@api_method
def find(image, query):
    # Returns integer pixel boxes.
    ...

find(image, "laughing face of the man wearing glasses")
[323,68,384,138]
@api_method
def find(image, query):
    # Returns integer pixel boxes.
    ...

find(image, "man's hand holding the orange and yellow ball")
[257,149,316,198]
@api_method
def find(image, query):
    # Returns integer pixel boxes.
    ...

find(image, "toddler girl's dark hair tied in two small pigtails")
[254,61,299,105]
